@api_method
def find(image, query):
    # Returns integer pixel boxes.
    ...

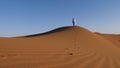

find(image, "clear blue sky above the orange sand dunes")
[0,0,120,37]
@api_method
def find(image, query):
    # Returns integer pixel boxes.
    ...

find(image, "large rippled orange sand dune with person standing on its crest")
[0,26,120,68]
